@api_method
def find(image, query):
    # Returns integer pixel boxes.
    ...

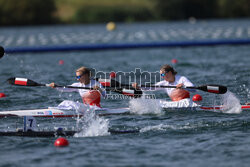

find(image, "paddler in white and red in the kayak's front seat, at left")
[50,67,106,107]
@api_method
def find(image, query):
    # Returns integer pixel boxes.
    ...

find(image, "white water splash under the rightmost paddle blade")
[221,91,242,114]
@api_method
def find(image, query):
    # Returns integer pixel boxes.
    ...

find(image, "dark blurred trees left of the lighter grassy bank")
[0,0,57,25]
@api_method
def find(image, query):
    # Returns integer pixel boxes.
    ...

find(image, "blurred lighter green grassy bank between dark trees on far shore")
[55,0,154,23]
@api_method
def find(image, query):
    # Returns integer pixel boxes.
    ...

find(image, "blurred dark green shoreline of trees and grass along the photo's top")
[0,0,250,26]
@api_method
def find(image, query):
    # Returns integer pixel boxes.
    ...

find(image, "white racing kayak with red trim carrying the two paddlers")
[0,99,250,117]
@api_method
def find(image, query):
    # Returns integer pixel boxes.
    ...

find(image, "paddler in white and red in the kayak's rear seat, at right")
[132,64,194,101]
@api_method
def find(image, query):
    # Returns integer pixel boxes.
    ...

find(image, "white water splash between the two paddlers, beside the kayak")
[129,97,163,115]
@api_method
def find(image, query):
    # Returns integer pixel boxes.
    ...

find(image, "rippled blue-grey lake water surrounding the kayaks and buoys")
[0,20,250,167]
